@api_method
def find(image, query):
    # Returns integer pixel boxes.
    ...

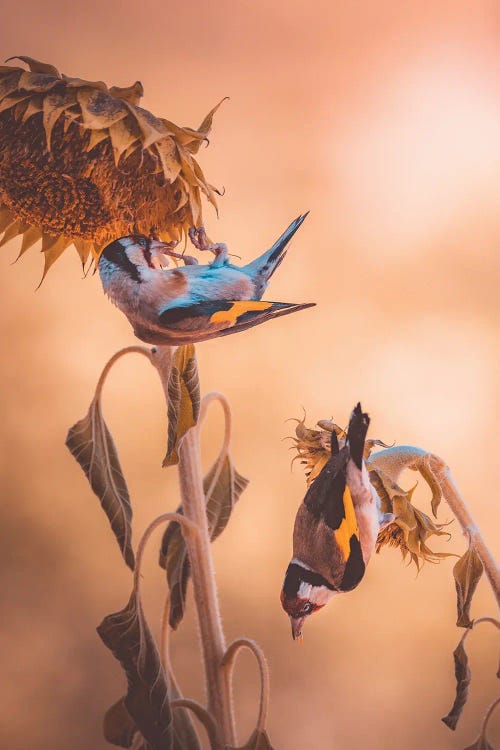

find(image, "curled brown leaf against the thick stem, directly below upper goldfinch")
[163,344,200,466]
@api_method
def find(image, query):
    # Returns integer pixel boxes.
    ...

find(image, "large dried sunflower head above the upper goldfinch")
[0,57,223,276]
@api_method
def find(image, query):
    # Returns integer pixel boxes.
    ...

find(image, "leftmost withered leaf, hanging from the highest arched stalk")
[66,398,135,570]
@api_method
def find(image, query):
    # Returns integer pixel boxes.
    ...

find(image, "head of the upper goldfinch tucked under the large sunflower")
[98,234,172,288]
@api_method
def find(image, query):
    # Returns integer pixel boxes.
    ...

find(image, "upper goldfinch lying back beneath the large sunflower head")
[98,214,314,345]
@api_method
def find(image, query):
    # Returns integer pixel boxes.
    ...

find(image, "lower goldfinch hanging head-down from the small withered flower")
[281,403,394,640]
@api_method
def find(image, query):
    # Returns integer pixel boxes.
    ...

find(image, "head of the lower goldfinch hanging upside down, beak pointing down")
[281,558,337,640]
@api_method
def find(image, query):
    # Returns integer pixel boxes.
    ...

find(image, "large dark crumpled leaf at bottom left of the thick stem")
[97,591,173,750]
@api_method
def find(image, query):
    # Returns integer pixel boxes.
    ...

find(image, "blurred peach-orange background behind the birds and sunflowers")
[0,0,500,750]
